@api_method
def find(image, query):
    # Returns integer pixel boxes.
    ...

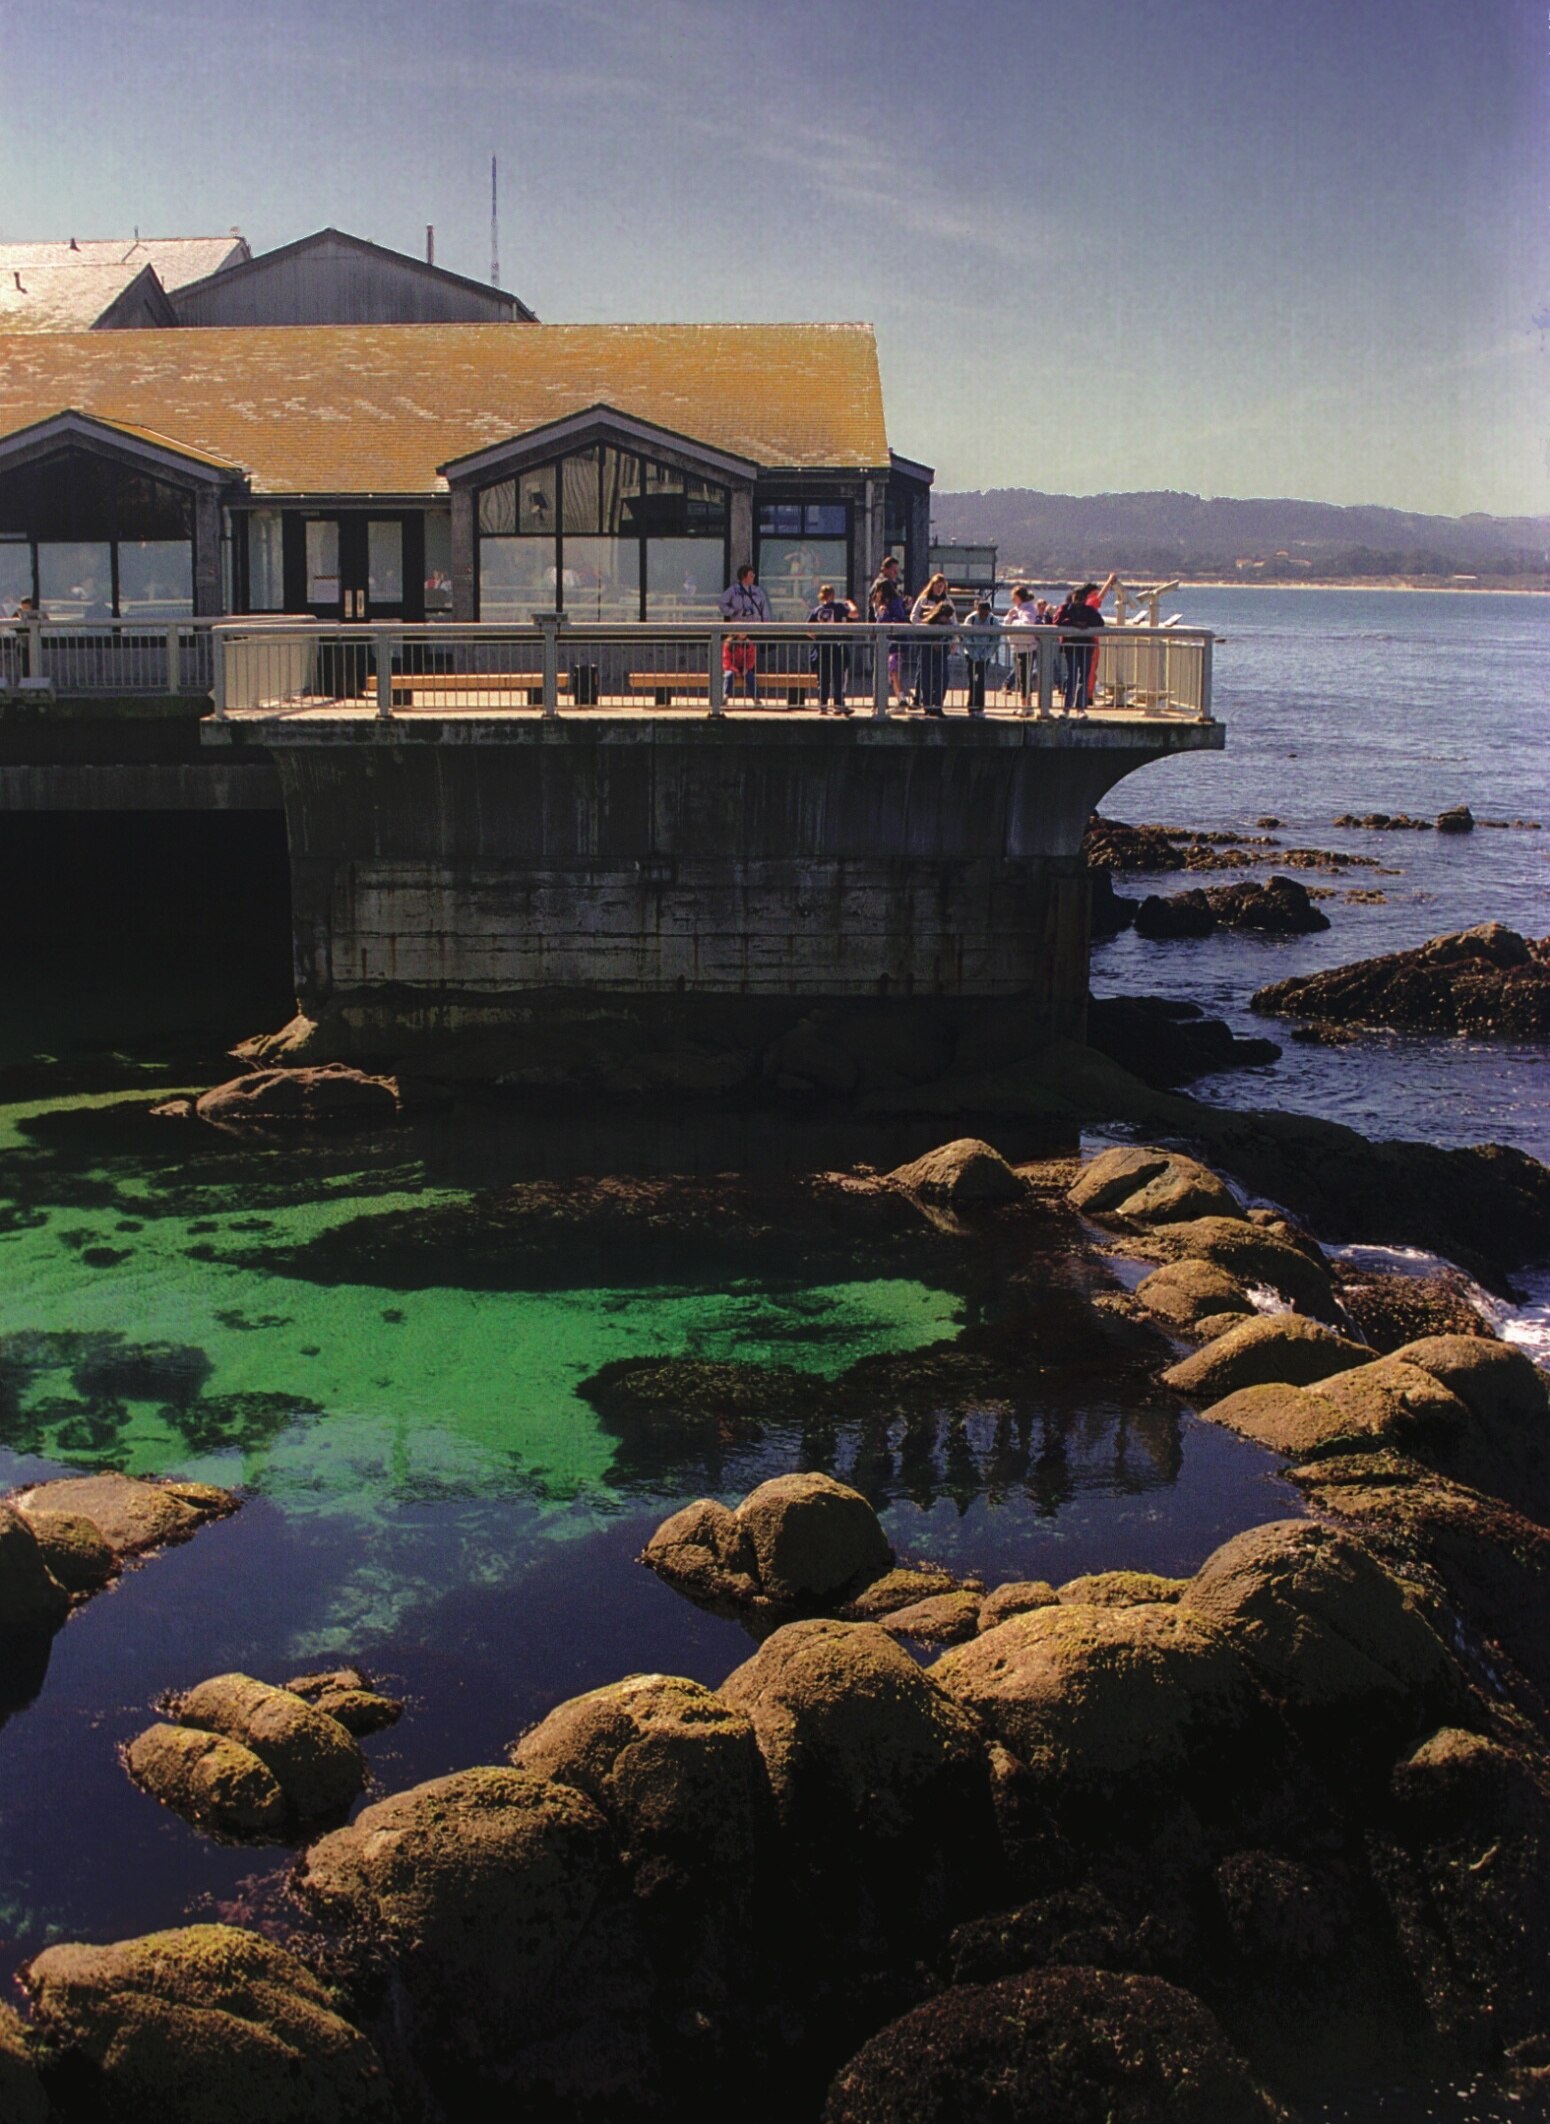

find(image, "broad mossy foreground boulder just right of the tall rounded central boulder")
[932,1601,1255,1795]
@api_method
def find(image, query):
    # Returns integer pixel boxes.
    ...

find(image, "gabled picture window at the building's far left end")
[0,450,193,620]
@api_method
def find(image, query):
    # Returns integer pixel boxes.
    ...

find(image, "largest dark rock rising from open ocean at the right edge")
[1253,922,1550,1041]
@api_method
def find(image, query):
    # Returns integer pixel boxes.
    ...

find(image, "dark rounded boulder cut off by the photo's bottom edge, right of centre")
[824,1969,1282,2124]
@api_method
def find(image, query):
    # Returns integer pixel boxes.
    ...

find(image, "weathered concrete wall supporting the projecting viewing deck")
[206,709,1221,1034]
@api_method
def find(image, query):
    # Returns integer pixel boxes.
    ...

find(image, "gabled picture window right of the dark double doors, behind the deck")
[476,444,728,624]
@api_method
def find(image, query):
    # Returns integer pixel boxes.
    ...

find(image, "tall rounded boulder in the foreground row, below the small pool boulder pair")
[720,1621,985,1848]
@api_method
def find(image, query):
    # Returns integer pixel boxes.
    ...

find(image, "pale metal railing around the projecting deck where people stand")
[204,614,1212,722]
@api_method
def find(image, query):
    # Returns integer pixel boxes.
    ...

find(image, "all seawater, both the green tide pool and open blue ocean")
[0,590,1550,2118]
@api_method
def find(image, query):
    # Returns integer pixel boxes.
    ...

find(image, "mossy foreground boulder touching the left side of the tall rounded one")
[510,1674,773,1882]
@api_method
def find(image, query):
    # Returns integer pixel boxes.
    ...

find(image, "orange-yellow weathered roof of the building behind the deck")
[0,323,888,495]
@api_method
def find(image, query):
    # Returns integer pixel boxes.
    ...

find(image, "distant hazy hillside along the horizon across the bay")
[932,486,1550,582]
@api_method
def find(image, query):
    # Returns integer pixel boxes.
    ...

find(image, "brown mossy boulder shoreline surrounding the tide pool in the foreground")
[0,1121,1550,2124]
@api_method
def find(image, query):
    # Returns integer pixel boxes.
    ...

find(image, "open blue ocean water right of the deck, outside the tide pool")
[1093,588,1550,1158]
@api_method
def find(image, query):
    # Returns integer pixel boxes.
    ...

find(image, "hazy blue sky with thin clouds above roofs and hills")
[0,0,1550,514]
